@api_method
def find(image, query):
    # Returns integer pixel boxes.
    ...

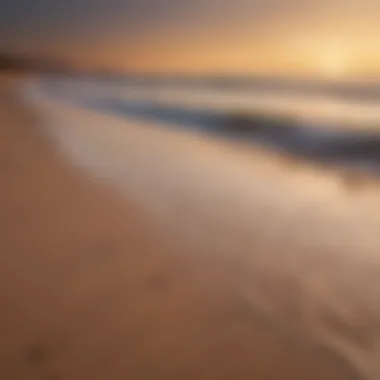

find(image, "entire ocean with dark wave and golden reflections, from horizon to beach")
[26,76,380,172]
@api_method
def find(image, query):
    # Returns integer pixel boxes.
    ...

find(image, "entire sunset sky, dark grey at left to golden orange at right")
[0,0,380,77]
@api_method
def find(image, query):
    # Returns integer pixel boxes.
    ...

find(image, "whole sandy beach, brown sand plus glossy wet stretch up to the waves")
[0,78,380,380]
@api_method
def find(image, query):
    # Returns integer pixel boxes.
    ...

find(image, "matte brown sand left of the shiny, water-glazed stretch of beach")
[0,81,359,380]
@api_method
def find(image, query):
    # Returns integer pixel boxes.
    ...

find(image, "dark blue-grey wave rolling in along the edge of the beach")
[33,76,380,174]
